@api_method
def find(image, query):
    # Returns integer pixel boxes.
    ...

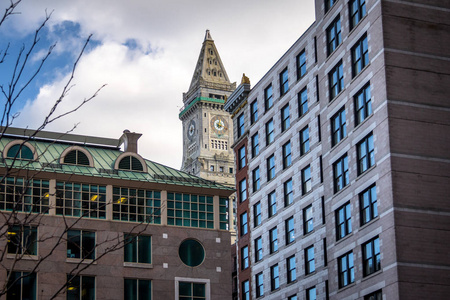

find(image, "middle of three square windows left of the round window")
[67,230,95,259]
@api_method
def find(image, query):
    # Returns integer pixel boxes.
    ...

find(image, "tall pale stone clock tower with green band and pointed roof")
[179,30,236,188]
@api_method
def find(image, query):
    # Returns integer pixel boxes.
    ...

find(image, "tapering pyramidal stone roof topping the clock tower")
[189,30,230,91]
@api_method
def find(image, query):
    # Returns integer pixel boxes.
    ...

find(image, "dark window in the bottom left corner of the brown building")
[6,272,38,300]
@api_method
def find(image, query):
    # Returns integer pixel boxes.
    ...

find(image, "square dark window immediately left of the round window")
[124,234,152,264]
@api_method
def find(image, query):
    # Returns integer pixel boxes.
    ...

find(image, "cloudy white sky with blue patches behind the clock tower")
[0,0,314,169]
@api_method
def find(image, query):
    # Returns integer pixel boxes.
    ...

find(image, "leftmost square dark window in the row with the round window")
[7,225,38,256]
